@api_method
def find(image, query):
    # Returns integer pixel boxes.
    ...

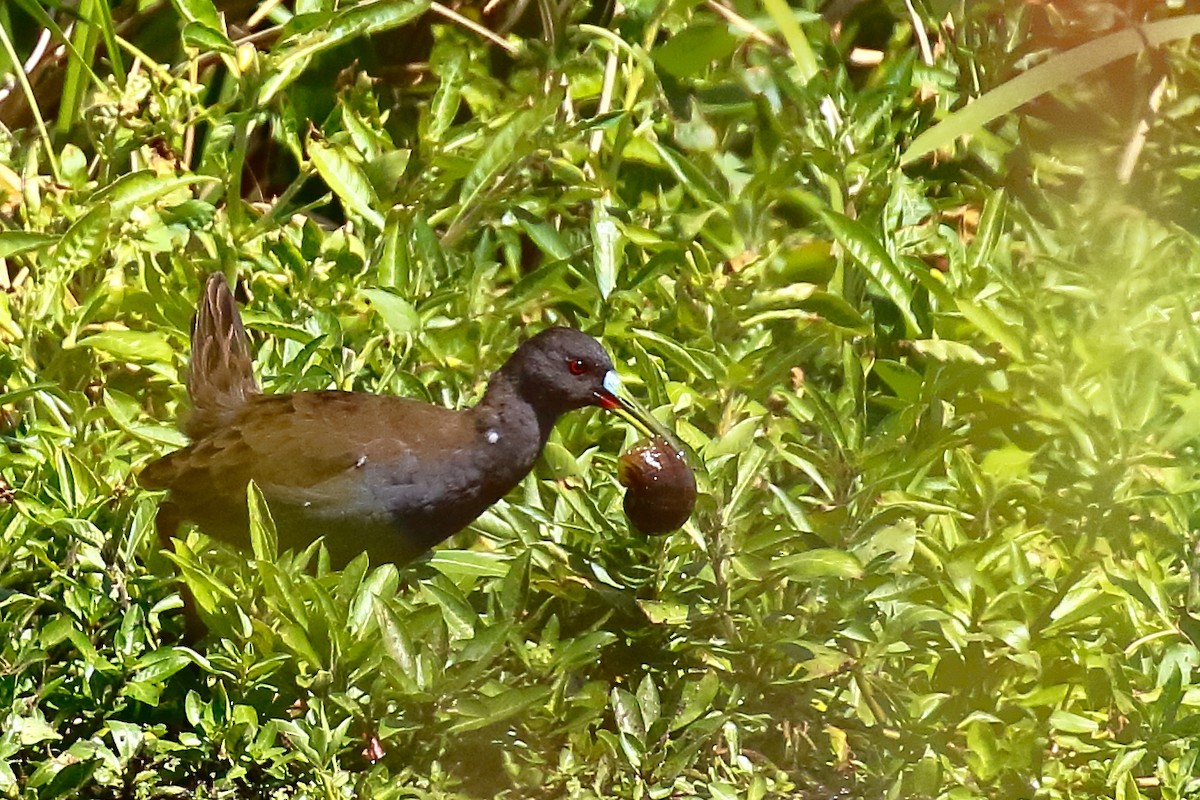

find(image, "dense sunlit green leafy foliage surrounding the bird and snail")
[0,0,1200,800]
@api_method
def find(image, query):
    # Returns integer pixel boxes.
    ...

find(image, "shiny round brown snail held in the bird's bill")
[617,437,696,534]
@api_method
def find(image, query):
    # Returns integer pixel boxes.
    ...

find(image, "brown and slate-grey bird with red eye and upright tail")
[140,272,648,566]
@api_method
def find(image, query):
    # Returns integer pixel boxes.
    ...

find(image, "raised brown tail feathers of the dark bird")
[184,272,260,439]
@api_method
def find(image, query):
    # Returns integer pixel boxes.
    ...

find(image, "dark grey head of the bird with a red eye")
[502,327,619,415]
